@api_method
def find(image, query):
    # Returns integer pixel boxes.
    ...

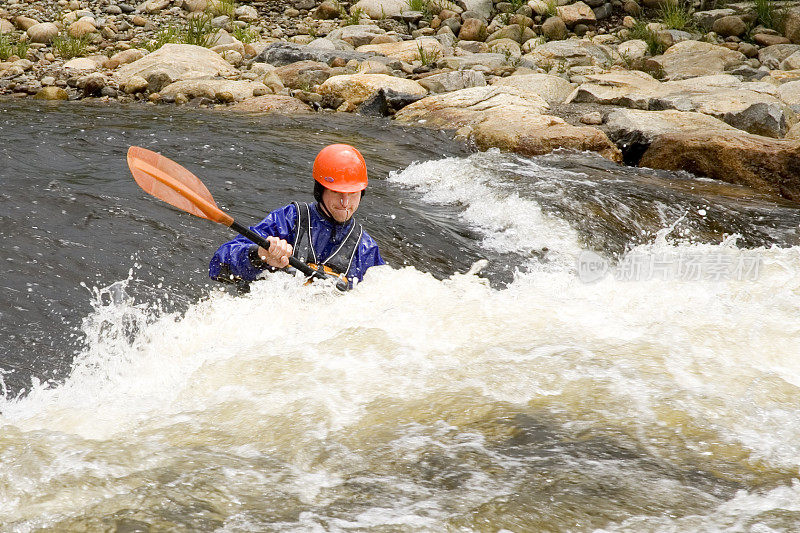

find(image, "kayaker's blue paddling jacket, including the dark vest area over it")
[209,203,386,286]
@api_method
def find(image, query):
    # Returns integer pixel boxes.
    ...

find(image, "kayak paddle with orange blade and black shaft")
[128,146,348,291]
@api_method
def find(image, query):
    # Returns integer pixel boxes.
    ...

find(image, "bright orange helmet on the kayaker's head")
[313,144,367,192]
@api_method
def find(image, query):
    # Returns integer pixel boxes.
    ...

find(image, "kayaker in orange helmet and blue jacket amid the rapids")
[209,144,385,289]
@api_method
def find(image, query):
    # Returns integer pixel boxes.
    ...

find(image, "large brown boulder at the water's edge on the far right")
[640,132,800,202]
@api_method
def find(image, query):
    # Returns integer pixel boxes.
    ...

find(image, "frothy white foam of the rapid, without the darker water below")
[0,152,800,529]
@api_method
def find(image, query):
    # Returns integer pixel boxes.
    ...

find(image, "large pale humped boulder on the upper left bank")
[114,44,236,86]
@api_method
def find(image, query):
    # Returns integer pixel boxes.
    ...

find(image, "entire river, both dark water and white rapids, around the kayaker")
[0,101,800,532]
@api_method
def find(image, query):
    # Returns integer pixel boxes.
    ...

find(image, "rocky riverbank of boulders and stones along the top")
[0,0,800,201]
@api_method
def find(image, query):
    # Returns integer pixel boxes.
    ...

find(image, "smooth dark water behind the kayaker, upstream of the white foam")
[0,101,477,391]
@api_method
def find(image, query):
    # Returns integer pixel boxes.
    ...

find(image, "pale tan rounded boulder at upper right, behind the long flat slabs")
[649,41,747,80]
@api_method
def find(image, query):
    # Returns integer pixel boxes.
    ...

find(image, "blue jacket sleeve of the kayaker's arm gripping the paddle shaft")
[208,204,297,282]
